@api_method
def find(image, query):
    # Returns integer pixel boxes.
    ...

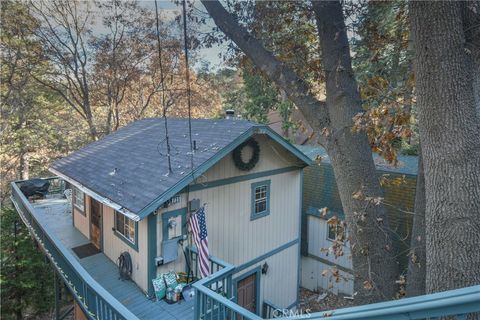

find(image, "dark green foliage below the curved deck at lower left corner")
[0,206,54,319]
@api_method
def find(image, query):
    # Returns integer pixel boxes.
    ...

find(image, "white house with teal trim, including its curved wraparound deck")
[12,119,312,319]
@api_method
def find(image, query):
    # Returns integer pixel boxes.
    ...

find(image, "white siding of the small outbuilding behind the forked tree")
[301,216,353,295]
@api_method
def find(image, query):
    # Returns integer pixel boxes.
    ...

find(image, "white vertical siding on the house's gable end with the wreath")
[157,135,301,307]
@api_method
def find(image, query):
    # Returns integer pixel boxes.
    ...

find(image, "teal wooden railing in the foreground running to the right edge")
[186,242,480,320]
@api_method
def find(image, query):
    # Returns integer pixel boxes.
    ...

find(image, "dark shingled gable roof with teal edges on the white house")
[51,118,311,219]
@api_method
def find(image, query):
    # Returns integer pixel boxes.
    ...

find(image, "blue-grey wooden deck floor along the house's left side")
[33,199,193,320]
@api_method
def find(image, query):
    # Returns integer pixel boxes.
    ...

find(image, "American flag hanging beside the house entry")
[188,207,210,278]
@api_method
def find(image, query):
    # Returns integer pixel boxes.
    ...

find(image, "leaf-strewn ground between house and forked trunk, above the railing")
[300,288,353,312]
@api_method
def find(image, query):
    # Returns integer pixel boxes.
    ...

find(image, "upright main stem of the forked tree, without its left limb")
[312,1,398,303]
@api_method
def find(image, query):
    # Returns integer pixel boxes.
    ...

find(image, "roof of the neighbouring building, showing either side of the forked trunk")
[295,145,418,175]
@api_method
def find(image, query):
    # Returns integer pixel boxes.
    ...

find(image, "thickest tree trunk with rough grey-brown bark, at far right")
[410,1,480,293]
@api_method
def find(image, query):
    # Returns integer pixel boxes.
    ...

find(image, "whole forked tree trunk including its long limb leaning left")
[202,0,397,303]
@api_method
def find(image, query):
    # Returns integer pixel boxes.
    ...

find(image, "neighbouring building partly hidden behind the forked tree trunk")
[297,146,418,296]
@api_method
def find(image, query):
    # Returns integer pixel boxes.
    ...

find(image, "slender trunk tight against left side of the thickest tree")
[407,150,427,297]
